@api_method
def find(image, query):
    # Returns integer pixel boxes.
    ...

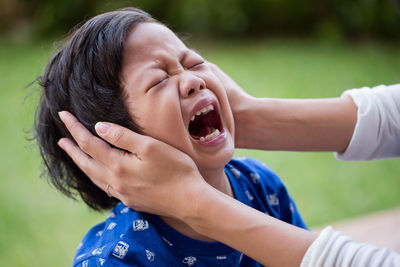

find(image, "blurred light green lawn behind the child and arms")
[0,37,400,266]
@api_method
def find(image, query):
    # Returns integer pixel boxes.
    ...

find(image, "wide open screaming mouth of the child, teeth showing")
[189,105,222,142]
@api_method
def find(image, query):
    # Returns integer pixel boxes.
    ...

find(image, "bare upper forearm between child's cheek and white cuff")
[233,97,357,152]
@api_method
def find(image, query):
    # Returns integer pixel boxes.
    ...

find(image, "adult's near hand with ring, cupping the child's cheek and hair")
[58,111,208,219]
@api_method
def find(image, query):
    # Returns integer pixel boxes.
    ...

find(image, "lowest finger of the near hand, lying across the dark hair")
[57,138,107,188]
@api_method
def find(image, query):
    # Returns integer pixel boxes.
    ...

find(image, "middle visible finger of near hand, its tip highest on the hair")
[59,111,119,163]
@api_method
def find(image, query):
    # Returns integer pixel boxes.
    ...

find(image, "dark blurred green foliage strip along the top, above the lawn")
[0,0,400,39]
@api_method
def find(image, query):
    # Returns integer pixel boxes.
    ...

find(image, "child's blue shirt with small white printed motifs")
[73,158,306,267]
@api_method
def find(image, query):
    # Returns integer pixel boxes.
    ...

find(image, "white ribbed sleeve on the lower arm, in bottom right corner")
[300,227,400,267]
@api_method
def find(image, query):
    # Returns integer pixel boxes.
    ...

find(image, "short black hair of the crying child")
[34,8,159,210]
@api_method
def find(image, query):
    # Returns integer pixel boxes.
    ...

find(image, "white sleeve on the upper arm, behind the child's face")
[335,84,400,160]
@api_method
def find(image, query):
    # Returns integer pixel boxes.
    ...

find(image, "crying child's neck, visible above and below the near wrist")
[160,168,233,242]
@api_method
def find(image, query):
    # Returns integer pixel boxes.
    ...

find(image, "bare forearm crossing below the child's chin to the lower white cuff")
[181,182,317,266]
